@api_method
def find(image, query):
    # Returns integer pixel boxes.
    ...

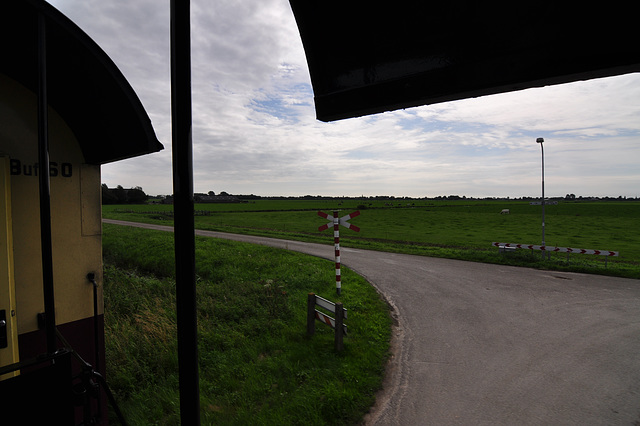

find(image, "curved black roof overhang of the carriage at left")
[0,0,163,164]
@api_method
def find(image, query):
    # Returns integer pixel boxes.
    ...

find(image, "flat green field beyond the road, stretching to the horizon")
[103,199,640,278]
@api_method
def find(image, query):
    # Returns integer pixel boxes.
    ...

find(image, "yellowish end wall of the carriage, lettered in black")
[0,74,102,334]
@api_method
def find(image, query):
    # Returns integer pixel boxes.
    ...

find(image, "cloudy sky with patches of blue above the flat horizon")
[49,0,640,198]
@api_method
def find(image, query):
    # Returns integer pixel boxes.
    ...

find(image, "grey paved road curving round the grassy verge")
[105,220,640,426]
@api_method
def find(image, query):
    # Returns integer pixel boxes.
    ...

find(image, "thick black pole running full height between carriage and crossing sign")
[171,0,200,425]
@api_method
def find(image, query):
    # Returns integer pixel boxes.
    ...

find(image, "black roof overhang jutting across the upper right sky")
[290,0,640,121]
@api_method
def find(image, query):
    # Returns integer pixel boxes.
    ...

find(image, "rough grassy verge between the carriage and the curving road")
[103,224,391,425]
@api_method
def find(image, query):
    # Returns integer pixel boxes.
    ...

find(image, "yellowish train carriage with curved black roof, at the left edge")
[0,0,162,424]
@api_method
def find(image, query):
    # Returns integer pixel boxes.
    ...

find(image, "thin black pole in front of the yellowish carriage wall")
[38,13,56,354]
